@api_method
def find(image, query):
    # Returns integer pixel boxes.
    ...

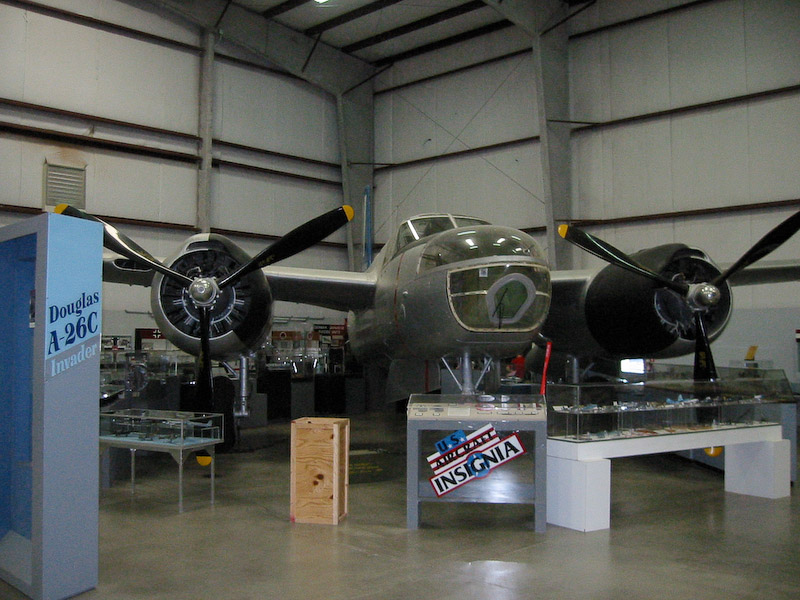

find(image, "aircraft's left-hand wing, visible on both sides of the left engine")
[103,257,376,311]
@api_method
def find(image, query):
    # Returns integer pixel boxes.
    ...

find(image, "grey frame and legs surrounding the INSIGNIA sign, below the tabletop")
[406,418,547,533]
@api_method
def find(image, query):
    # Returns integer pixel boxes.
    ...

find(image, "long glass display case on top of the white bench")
[547,367,793,442]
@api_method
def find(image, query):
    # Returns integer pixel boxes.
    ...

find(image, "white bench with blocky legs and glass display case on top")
[547,376,791,531]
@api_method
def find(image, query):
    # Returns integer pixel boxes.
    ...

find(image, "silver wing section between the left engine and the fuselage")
[263,267,377,310]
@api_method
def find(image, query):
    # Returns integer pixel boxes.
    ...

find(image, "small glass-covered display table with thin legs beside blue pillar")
[100,408,225,512]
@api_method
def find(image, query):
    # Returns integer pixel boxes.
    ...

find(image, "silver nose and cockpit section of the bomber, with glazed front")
[348,218,550,360]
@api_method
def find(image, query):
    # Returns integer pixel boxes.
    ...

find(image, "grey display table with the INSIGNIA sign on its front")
[406,394,547,532]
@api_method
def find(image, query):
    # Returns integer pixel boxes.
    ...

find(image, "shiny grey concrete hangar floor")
[0,415,800,600]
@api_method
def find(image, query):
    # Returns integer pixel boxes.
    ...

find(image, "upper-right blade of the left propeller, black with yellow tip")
[219,205,354,288]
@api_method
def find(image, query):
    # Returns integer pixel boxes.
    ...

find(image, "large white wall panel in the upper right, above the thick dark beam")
[570,0,800,121]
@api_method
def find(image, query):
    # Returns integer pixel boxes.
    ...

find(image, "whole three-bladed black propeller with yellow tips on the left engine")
[56,204,354,406]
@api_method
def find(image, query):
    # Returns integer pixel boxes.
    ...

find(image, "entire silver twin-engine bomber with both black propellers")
[54,207,800,410]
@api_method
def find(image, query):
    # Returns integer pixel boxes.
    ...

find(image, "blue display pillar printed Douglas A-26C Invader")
[0,214,103,600]
